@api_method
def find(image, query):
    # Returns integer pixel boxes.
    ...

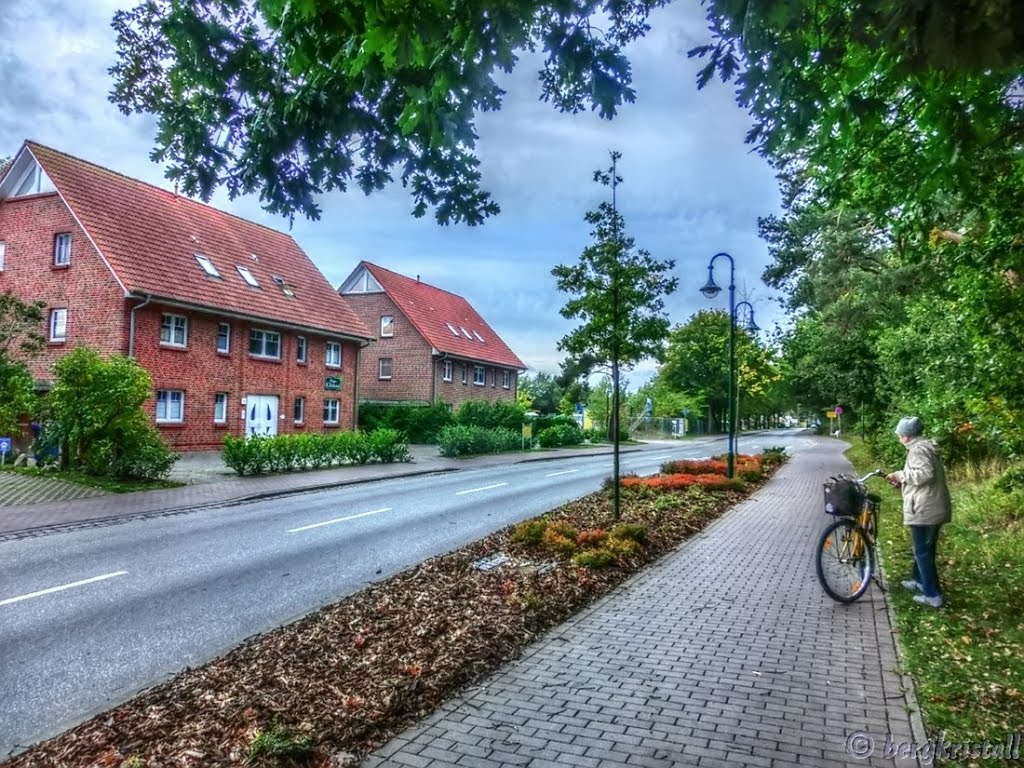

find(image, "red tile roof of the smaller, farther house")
[360,261,526,370]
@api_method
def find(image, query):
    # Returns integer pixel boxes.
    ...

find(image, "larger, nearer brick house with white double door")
[0,141,371,451]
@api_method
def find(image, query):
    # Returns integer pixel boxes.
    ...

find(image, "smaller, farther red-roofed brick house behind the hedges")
[338,261,526,407]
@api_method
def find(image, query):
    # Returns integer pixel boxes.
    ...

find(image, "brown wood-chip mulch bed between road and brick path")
[2,462,782,768]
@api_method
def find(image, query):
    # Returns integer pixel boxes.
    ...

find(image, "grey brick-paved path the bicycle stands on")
[364,440,924,768]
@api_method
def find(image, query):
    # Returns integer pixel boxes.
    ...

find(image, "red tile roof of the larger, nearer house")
[26,141,371,338]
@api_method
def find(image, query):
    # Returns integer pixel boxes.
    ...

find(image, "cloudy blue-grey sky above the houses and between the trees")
[0,0,781,384]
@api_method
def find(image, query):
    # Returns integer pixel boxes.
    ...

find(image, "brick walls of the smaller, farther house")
[345,293,517,408]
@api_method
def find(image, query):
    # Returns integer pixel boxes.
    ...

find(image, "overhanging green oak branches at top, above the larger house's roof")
[111,0,668,224]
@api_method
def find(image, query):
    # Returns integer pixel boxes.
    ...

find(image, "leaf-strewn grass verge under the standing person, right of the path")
[847,440,1024,742]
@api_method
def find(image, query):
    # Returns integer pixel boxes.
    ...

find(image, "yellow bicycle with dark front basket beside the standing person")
[814,469,885,603]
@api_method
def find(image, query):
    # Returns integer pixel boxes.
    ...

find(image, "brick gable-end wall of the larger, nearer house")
[0,193,128,381]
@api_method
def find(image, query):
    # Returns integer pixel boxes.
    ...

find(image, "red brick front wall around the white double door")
[135,304,357,450]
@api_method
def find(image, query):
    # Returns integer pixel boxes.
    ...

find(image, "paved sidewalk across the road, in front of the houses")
[0,445,655,541]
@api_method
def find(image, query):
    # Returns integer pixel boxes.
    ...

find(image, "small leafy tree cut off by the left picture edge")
[0,294,45,435]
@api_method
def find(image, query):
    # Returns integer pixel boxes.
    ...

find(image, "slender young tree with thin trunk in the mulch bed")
[551,152,679,519]
